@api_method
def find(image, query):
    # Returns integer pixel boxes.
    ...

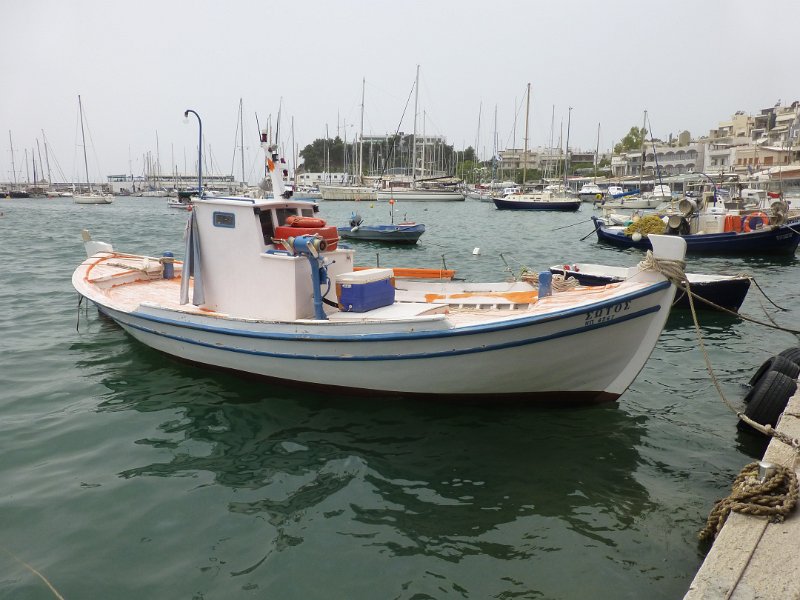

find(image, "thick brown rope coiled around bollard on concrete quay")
[698,462,798,540]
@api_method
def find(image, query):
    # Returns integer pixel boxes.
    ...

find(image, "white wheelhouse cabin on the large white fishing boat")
[187,197,353,321]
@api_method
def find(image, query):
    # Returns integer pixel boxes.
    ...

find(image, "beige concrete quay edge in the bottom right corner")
[684,391,800,600]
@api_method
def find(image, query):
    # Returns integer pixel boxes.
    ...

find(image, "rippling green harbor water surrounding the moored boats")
[0,198,800,600]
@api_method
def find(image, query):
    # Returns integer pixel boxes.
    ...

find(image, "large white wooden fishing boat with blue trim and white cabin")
[72,131,685,403]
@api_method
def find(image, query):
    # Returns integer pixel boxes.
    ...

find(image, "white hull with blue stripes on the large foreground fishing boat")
[78,272,674,402]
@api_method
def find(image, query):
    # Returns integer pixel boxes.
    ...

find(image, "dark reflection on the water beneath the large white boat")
[89,343,655,561]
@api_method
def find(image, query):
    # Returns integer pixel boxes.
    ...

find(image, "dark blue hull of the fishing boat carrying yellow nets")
[592,217,800,255]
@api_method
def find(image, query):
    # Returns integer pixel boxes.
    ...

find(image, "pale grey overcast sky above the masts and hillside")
[0,0,800,182]
